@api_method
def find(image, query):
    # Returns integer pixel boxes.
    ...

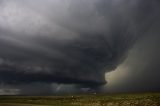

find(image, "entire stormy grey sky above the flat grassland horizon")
[0,0,160,95]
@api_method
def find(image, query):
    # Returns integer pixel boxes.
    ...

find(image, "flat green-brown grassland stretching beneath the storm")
[0,93,160,106]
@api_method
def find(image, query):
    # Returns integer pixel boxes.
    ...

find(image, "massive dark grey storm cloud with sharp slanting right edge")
[0,0,159,93]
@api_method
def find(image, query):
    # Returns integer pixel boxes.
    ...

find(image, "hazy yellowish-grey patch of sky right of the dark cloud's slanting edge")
[107,32,160,92]
